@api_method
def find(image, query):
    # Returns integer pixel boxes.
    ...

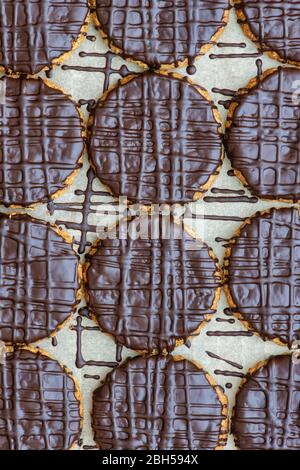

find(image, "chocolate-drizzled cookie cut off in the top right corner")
[235,0,300,64]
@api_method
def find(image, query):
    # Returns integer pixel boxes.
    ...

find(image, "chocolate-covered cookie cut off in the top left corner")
[0,0,88,74]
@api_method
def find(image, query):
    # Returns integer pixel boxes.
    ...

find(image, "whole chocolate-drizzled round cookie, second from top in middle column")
[90,72,223,204]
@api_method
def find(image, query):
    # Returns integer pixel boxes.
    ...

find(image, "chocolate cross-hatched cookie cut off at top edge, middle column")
[96,0,229,67]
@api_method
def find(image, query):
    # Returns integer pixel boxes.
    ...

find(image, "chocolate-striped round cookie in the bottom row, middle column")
[92,356,227,450]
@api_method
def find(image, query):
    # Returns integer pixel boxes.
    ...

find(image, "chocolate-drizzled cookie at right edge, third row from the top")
[225,208,300,345]
